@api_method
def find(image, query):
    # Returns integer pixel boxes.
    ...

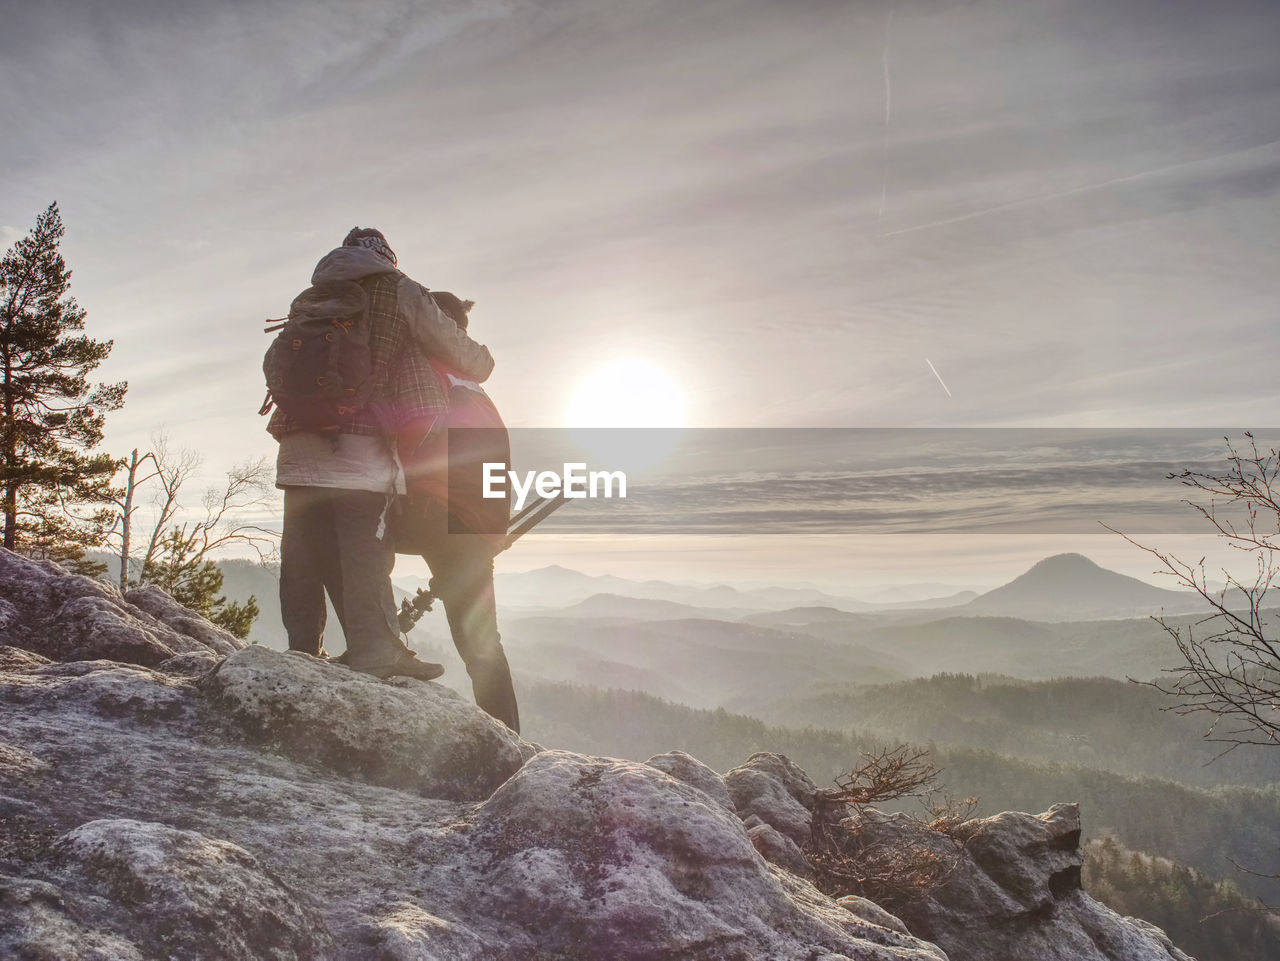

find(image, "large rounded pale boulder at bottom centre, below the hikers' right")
[455,751,942,961]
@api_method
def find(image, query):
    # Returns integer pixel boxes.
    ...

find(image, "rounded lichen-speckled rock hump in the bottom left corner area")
[52,820,330,961]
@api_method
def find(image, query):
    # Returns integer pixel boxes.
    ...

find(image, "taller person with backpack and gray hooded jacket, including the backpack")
[261,228,493,679]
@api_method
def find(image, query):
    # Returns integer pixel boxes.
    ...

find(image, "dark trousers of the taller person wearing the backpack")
[280,488,403,665]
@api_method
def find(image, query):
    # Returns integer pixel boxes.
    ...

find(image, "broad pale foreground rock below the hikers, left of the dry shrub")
[0,647,943,961]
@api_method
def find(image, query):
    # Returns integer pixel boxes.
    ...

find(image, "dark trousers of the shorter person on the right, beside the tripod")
[415,504,520,733]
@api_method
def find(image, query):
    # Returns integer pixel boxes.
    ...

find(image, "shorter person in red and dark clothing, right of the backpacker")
[396,290,520,733]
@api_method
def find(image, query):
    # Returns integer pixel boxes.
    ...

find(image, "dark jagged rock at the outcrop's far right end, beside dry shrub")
[852,805,1190,961]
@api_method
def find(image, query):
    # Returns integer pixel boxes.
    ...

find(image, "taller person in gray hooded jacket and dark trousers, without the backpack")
[268,228,493,679]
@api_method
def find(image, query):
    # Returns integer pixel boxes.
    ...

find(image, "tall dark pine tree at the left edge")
[0,202,128,562]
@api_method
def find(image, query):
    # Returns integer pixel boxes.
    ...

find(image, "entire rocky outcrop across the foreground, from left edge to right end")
[0,552,1181,961]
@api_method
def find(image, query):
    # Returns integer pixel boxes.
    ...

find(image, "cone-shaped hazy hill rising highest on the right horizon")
[960,554,1203,621]
